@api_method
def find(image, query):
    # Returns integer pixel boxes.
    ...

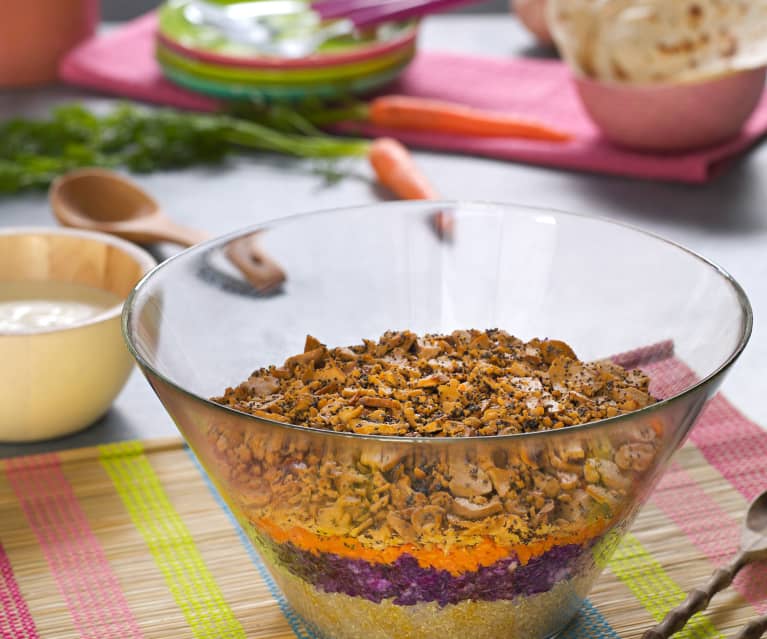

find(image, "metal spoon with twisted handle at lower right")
[642,490,767,639]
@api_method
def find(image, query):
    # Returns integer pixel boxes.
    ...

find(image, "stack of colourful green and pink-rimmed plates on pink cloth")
[156,0,418,102]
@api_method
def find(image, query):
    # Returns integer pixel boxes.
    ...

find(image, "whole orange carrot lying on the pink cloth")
[367,95,572,142]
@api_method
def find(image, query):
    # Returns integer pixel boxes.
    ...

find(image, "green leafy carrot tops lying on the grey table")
[0,104,368,194]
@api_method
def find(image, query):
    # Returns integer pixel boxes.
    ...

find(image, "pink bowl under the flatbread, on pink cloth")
[575,67,767,151]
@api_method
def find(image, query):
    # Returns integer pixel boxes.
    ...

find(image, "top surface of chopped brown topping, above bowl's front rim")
[214,329,655,437]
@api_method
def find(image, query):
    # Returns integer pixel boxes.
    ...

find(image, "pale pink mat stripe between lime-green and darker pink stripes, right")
[650,464,767,614]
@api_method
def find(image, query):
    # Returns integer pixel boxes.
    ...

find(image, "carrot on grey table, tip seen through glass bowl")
[368,138,453,239]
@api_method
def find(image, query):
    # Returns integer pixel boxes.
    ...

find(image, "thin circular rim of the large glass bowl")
[121,200,754,446]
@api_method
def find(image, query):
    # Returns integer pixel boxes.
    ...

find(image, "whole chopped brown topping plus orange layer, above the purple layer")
[207,330,665,552]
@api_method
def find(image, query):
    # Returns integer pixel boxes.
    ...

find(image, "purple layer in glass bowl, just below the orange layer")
[258,536,594,606]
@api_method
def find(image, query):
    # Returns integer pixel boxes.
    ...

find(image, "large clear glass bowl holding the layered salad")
[123,202,752,639]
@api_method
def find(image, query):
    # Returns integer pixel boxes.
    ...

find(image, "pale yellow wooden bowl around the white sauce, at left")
[0,228,155,442]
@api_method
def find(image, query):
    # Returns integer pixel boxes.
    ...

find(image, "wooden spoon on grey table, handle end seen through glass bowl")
[48,168,285,293]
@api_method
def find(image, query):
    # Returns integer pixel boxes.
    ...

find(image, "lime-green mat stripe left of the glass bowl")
[99,442,245,639]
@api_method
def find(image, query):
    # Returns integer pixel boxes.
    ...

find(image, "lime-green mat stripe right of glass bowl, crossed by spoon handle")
[608,533,723,639]
